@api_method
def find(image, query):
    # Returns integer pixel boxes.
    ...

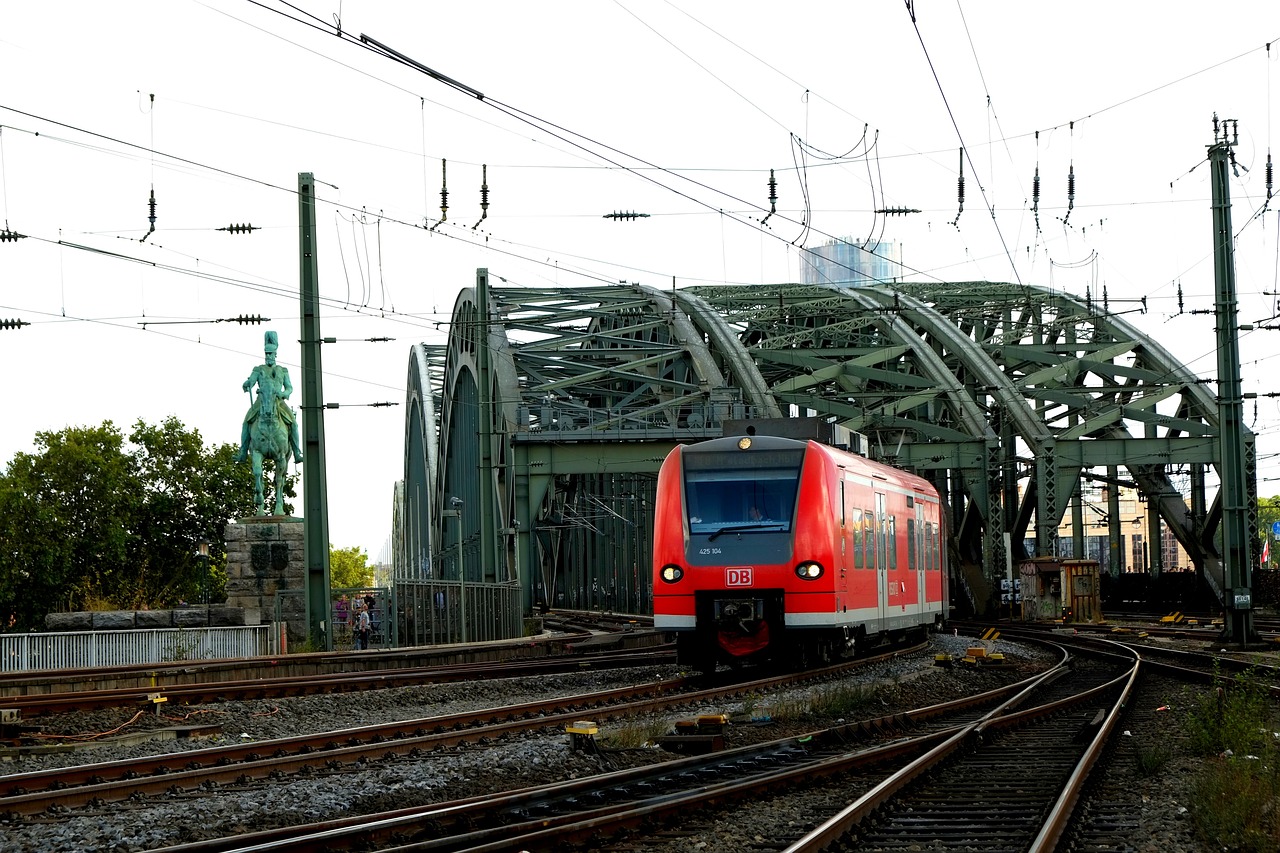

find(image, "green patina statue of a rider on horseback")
[234,332,302,515]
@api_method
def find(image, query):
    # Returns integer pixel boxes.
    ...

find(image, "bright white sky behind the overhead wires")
[0,0,1280,557]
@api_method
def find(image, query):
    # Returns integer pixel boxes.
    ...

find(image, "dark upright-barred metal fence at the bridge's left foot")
[396,580,525,646]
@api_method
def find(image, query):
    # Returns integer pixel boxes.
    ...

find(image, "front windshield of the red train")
[684,448,804,534]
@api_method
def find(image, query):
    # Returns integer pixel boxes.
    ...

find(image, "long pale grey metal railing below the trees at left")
[0,625,275,672]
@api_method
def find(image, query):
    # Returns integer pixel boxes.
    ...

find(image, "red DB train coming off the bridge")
[653,435,948,671]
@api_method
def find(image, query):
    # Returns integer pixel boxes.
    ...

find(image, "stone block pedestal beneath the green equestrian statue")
[225,515,310,643]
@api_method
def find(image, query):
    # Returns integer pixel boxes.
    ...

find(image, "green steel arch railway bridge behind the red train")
[394,270,1258,627]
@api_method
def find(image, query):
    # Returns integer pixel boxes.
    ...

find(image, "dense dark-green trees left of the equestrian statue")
[0,418,253,629]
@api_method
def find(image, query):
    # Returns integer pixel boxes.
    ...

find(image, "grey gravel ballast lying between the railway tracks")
[0,634,1228,853]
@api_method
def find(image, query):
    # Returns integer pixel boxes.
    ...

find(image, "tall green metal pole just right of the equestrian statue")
[298,172,333,651]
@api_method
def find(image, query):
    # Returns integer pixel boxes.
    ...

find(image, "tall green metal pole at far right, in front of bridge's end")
[1208,115,1257,643]
